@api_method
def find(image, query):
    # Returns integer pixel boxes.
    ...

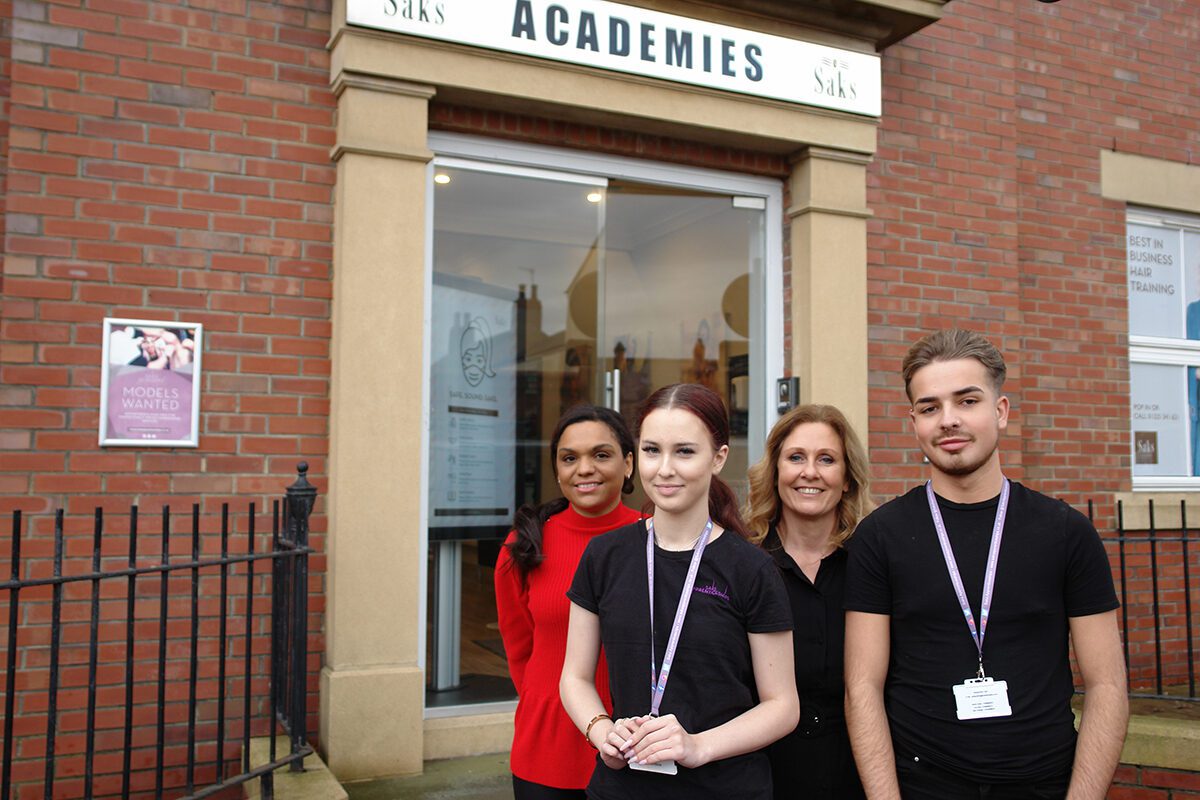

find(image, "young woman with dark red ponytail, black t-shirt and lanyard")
[559,384,799,800]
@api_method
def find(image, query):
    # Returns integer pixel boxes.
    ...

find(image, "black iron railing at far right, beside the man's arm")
[1088,500,1200,702]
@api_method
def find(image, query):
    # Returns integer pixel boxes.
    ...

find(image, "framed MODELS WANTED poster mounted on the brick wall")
[100,318,203,447]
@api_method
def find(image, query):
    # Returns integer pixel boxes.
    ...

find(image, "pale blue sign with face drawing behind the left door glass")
[430,276,516,528]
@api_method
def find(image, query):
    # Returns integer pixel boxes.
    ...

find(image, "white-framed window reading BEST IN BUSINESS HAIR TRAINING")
[1126,210,1200,488]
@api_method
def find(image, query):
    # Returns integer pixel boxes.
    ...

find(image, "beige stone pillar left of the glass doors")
[320,72,433,781]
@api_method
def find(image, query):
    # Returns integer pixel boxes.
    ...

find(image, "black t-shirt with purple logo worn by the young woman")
[566,522,792,800]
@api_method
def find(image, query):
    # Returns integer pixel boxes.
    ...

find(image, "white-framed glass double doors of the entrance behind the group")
[426,134,782,714]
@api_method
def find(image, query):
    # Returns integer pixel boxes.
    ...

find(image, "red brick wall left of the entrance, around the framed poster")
[0,0,335,796]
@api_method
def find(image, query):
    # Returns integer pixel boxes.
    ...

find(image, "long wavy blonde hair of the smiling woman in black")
[743,403,874,547]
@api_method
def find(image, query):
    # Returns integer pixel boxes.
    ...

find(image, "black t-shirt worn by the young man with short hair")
[846,482,1118,782]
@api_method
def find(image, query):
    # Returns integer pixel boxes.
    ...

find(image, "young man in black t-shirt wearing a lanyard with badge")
[846,330,1128,800]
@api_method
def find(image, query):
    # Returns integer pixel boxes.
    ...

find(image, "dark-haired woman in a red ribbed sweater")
[496,405,641,800]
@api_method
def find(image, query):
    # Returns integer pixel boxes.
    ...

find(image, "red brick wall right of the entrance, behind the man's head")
[869,0,1200,513]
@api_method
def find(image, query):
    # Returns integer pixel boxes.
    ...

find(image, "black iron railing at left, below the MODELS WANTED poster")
[0,463,317,800]
